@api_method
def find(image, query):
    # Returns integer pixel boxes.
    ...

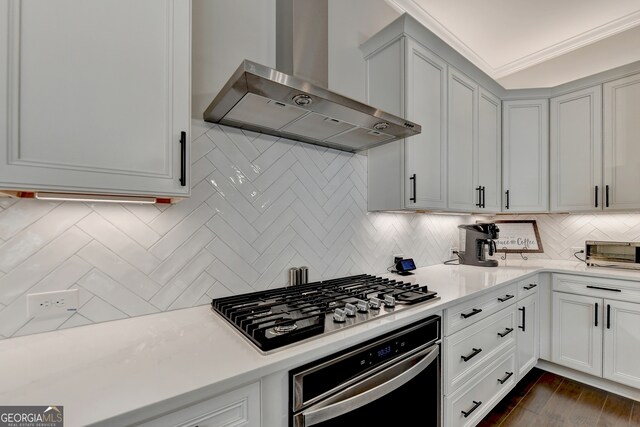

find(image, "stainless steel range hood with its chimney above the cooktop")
[204,0,421,152]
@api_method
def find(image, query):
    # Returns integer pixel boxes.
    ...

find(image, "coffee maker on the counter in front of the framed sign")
[458,223,500,267]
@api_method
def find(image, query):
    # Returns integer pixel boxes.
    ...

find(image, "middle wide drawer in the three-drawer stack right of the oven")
[444,304,517,394]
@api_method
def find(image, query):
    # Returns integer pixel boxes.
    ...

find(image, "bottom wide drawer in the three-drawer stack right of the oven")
[445,350,516,427]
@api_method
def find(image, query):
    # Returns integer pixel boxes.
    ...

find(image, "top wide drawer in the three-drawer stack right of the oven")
[444,283,517,335]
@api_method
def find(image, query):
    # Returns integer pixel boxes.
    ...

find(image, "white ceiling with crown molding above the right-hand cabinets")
[386,0,640,89]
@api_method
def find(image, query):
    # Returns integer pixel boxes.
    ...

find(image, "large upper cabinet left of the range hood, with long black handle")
[0,0,191,197]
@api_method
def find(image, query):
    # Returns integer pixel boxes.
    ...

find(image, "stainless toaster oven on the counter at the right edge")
[585,240,640,269]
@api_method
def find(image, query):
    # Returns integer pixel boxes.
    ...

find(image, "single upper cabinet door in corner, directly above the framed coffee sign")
[502,99,549,213]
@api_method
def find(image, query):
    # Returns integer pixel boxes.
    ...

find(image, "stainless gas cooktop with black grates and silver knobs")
[211,274,440,351]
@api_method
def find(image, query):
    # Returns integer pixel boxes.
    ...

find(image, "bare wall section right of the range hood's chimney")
[329,0,400,102]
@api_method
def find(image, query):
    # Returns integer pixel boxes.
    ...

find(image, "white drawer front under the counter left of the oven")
[137,382,260,427]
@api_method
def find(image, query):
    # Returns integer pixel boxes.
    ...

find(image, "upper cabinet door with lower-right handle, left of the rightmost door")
[550,85,605,212]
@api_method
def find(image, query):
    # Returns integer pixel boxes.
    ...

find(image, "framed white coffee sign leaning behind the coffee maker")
[494,220,544,253]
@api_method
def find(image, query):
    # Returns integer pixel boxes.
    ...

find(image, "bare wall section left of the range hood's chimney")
[191,0,276,119]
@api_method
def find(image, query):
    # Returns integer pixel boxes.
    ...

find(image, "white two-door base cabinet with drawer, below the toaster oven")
[551,274,640,388]
